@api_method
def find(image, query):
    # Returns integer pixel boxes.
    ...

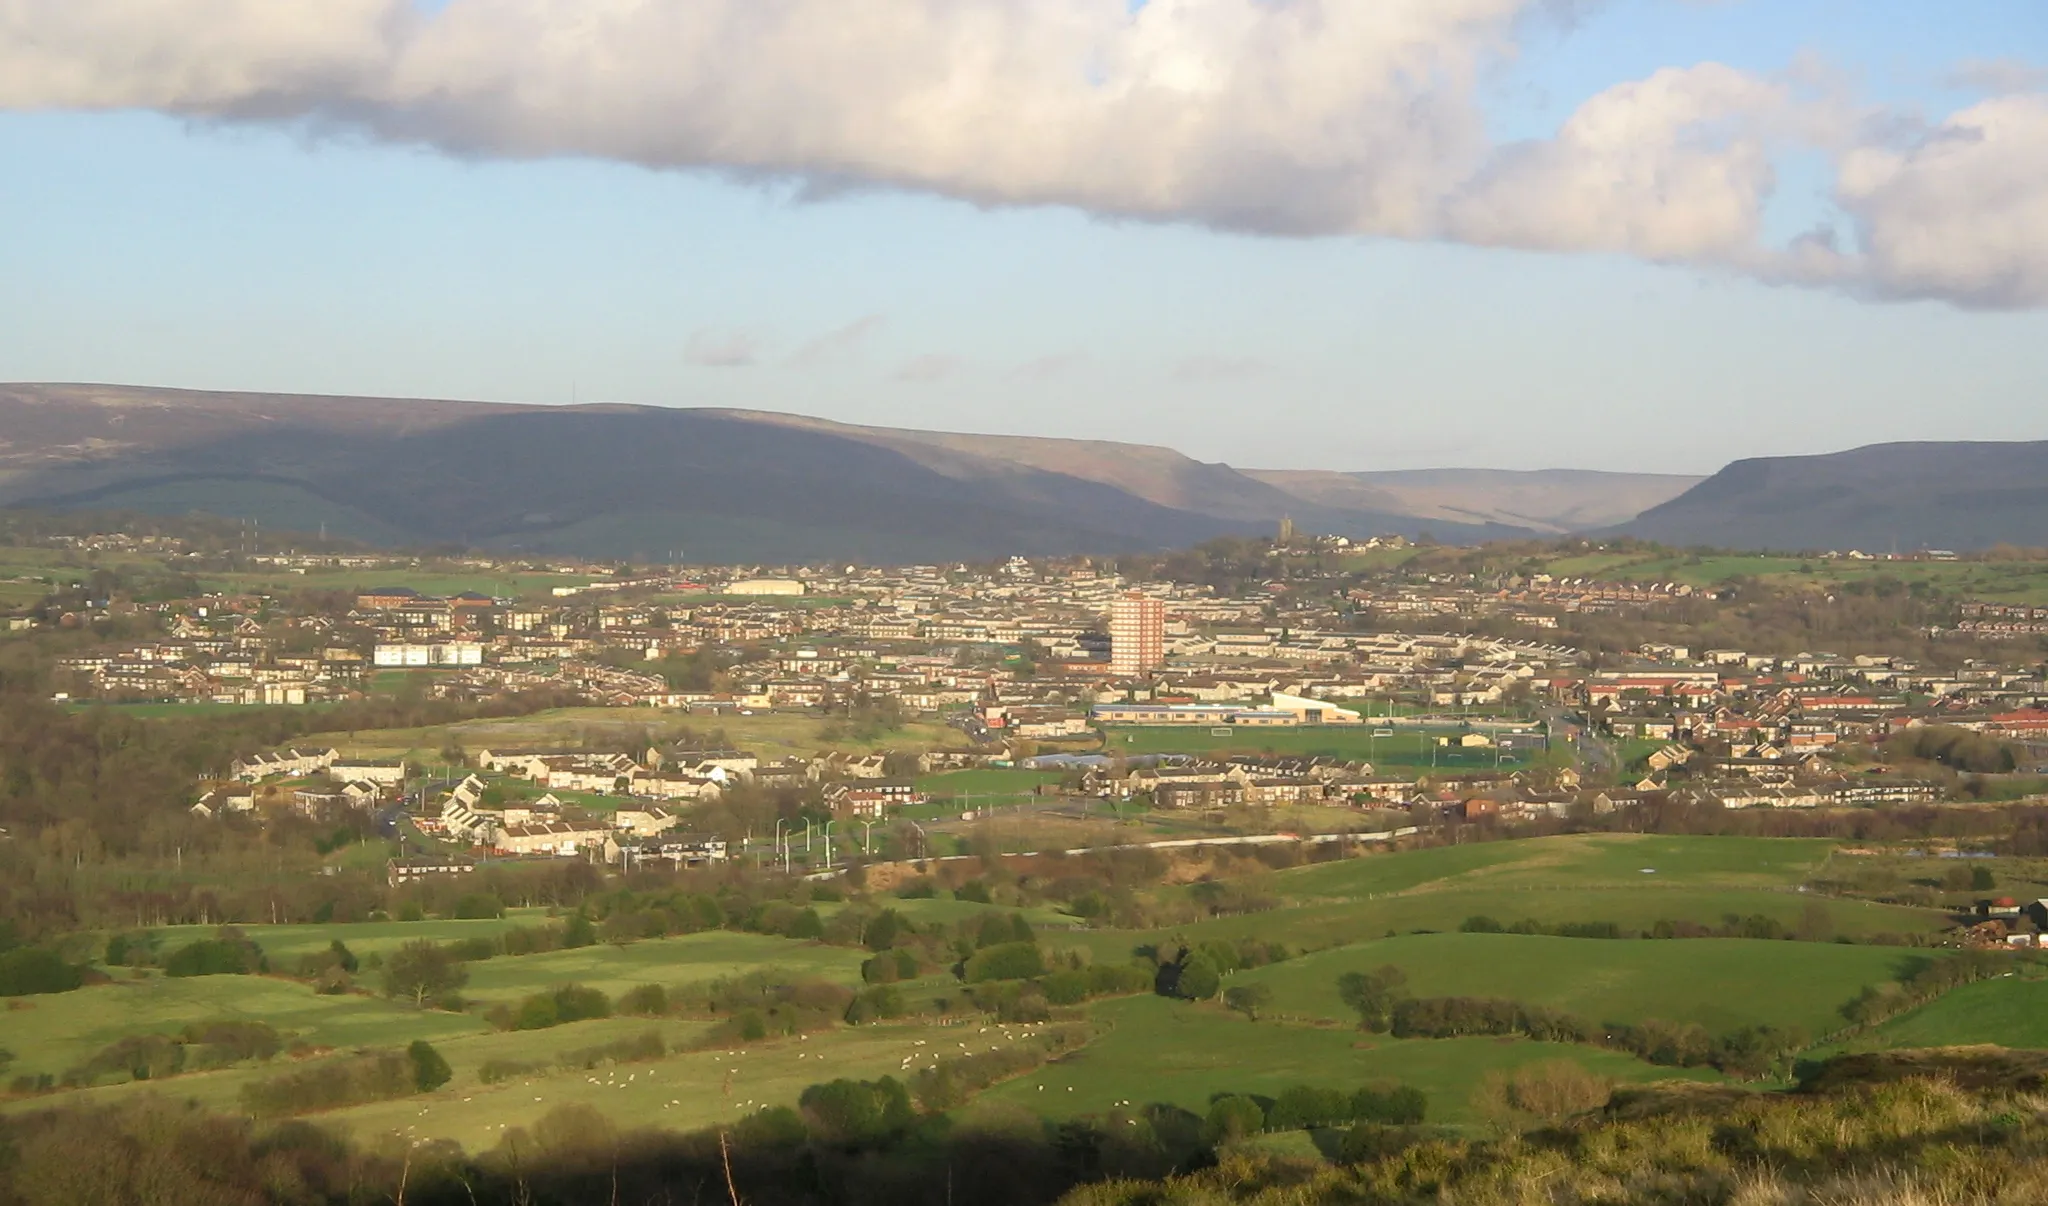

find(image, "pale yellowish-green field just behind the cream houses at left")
[297,708,967,760]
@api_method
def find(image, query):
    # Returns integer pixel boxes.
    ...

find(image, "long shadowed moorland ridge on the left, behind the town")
[0,385,1530,563]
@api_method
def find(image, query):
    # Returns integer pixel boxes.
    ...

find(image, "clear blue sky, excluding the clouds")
[0,0,2048,471]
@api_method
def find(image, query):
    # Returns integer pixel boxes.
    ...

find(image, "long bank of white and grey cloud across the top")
[0,0,2048,307]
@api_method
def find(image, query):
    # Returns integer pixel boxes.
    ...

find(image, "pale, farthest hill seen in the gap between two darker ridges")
[1245,469,1702,534]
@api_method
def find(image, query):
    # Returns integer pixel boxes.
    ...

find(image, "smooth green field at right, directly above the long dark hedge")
[1231,934,1915,1034]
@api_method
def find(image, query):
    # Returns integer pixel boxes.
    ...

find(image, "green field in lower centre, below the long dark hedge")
[983,997,1712,1124]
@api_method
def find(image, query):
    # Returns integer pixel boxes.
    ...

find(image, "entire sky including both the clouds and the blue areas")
[0,0,2048,473]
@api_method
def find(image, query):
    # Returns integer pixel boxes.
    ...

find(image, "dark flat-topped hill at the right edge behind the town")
[1616,442,2048,553]
